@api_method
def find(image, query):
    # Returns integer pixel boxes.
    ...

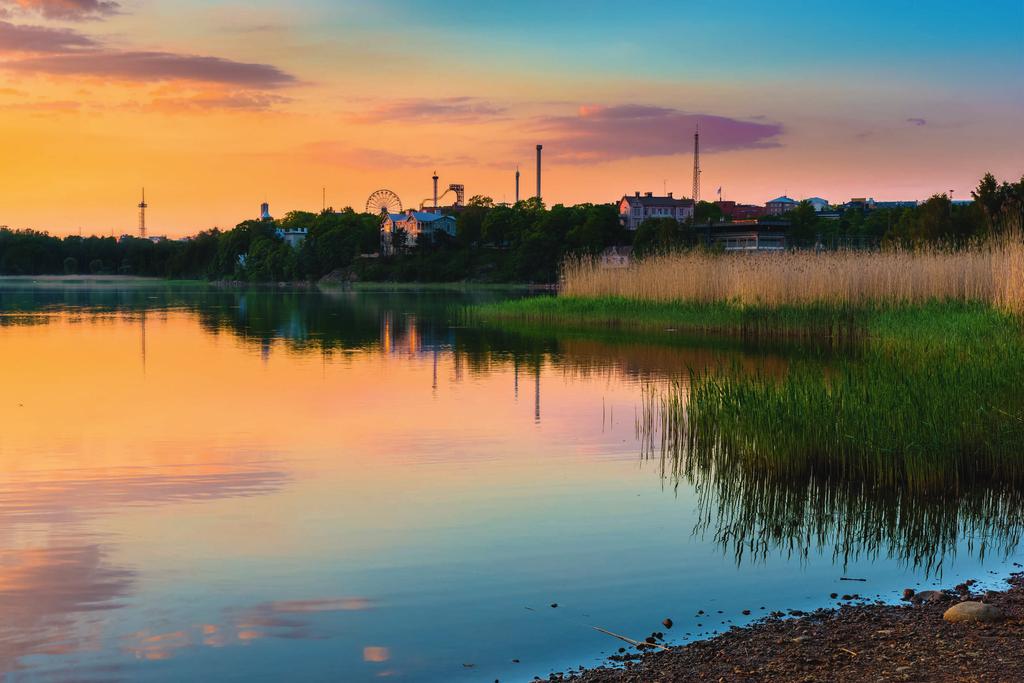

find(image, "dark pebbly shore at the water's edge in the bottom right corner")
[557,564,1024,683]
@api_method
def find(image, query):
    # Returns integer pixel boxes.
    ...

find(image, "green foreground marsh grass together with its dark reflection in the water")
[637,303,1024,571]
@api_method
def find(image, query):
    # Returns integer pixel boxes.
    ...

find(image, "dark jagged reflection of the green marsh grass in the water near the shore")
[638,397,1024,575]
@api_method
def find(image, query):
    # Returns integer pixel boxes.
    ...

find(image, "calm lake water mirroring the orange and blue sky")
[0,282,1019,681]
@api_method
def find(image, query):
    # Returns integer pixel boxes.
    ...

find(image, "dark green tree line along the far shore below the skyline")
[0,174,1024,283]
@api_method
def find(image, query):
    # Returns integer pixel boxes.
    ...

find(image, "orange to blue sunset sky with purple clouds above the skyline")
[0,0,1024,236]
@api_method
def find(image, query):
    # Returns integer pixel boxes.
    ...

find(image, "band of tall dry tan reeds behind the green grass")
[562,232,1024,312]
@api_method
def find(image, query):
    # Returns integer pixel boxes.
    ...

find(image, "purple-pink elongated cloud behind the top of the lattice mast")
[537,104,783,163]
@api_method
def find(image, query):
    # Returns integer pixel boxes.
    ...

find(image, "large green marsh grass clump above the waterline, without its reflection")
[638,303,1024,485]
